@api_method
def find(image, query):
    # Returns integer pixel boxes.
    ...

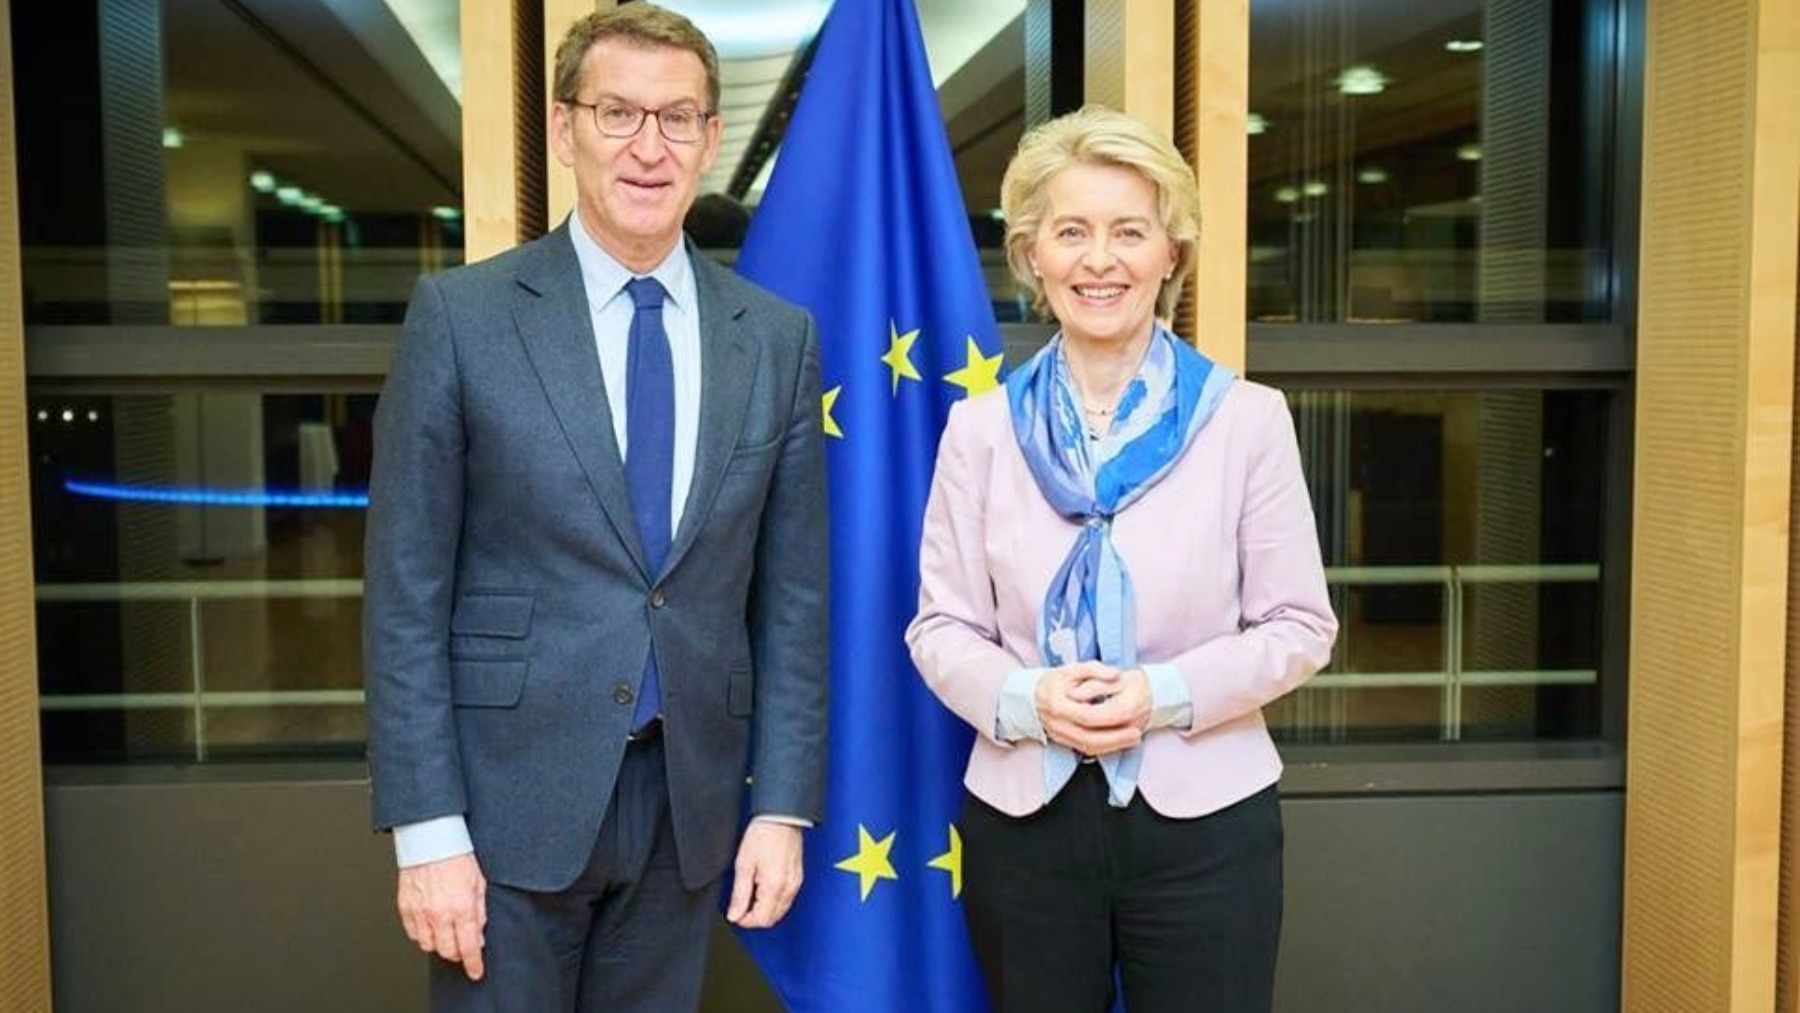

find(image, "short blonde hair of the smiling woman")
[1001,104,1201,318]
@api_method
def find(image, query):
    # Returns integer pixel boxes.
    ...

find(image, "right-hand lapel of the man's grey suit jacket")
[664,245,756,570]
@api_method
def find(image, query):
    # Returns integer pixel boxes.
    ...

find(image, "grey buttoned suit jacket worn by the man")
[364,225,828,891]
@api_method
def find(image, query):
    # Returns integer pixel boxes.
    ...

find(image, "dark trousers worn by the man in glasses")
[432,741,718,1013]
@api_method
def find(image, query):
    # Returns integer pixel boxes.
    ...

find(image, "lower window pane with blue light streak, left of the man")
[29,390,374,763]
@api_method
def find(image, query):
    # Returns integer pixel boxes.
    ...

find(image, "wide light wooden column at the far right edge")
[1622,0,1800,1013]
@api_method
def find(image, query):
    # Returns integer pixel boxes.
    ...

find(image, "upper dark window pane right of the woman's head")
[1249,0,1613,324]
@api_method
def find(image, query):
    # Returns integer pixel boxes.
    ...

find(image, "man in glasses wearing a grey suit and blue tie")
[364,2,828,1013]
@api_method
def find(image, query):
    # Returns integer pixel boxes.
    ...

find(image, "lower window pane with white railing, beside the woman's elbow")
[1269,390,1609,741]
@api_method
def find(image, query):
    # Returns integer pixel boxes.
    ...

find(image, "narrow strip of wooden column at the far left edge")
[0,0,50,1013]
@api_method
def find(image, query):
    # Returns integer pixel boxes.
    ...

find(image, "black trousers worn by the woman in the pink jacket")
[961,763,1282,1013]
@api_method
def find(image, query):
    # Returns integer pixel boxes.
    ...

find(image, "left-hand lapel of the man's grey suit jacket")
[513,221,652,579]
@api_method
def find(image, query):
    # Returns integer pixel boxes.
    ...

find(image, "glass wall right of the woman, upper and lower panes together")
[1247,0,1636,743]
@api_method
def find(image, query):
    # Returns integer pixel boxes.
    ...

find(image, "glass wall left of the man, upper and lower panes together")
[11,0,463,763]
